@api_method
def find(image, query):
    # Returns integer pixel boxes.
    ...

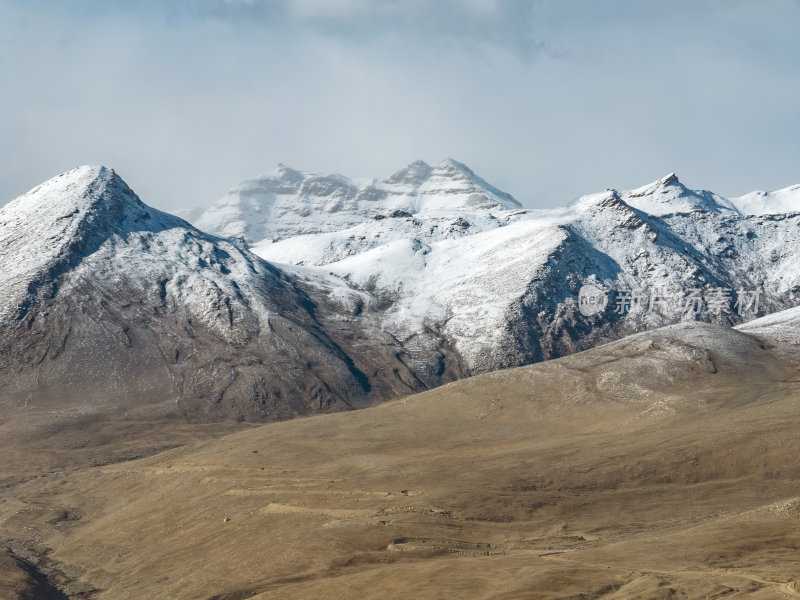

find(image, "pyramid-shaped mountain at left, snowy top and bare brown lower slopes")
[0,167,432,419]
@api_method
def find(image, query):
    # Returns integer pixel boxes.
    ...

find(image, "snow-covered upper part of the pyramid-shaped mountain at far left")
[0,166,231,319]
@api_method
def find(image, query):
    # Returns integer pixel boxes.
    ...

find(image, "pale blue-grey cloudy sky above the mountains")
[0,0,800,209]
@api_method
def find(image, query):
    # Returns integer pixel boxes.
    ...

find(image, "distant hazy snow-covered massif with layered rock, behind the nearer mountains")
[194,159,521,244]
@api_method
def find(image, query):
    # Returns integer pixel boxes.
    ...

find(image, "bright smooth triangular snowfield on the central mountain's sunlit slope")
[326,221,567,369]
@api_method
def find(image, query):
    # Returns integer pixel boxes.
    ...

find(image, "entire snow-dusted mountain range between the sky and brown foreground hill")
[0,160,800,421]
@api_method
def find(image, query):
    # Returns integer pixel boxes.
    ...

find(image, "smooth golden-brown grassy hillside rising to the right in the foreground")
[0,323,800,600]
